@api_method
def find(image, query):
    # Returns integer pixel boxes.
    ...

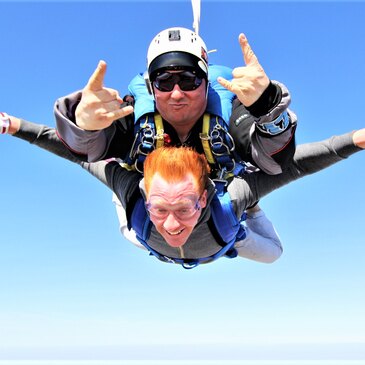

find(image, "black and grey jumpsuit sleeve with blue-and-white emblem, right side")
[229,81,297,175]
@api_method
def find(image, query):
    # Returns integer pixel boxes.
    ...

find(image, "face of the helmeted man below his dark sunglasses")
[153,71,207,129]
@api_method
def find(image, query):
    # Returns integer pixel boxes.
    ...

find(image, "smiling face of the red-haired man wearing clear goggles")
[147,173,207,247]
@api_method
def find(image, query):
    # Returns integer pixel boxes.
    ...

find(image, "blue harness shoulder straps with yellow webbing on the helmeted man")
[125,65,245,178]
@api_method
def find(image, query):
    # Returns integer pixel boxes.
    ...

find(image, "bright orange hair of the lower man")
[143,147,210,193]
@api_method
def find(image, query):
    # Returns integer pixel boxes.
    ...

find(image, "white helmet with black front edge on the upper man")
[147,27,208,79]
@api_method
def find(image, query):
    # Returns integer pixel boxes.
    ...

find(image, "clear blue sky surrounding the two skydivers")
[0,0,365,360]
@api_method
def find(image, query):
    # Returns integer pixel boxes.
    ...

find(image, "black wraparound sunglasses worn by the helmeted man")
[153,71,203,92]
